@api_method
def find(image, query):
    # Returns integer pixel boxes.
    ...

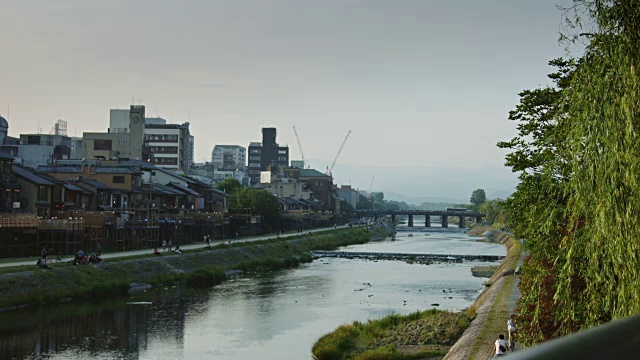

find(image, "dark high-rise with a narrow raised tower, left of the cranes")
[248,128,289,184]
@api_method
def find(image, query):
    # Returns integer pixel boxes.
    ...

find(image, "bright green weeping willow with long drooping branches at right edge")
[554,0,640,334]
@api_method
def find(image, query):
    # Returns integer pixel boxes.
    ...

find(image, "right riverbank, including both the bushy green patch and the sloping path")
[313,227,520,360]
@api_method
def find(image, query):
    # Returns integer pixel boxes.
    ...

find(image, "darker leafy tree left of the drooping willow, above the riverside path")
[498,59,577,344]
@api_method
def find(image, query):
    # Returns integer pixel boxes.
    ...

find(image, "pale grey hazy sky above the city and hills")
[0,0,568,201]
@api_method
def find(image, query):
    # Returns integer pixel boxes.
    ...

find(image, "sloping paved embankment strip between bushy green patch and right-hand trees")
[445,226,521,359]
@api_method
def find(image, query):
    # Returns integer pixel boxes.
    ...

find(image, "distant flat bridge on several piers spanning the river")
[356,209,487,228]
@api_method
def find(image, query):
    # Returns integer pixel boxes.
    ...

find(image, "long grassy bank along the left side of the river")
[0,227,384,309]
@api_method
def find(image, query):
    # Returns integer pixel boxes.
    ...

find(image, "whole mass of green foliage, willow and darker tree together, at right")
[498,0,640,344]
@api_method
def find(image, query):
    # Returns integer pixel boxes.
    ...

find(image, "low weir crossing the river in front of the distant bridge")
[313,250,504,262]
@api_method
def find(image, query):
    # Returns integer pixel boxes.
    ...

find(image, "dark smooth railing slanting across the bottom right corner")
[505,314,640,360]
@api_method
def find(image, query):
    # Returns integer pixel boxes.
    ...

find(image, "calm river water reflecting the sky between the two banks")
[0,232,506,360]
